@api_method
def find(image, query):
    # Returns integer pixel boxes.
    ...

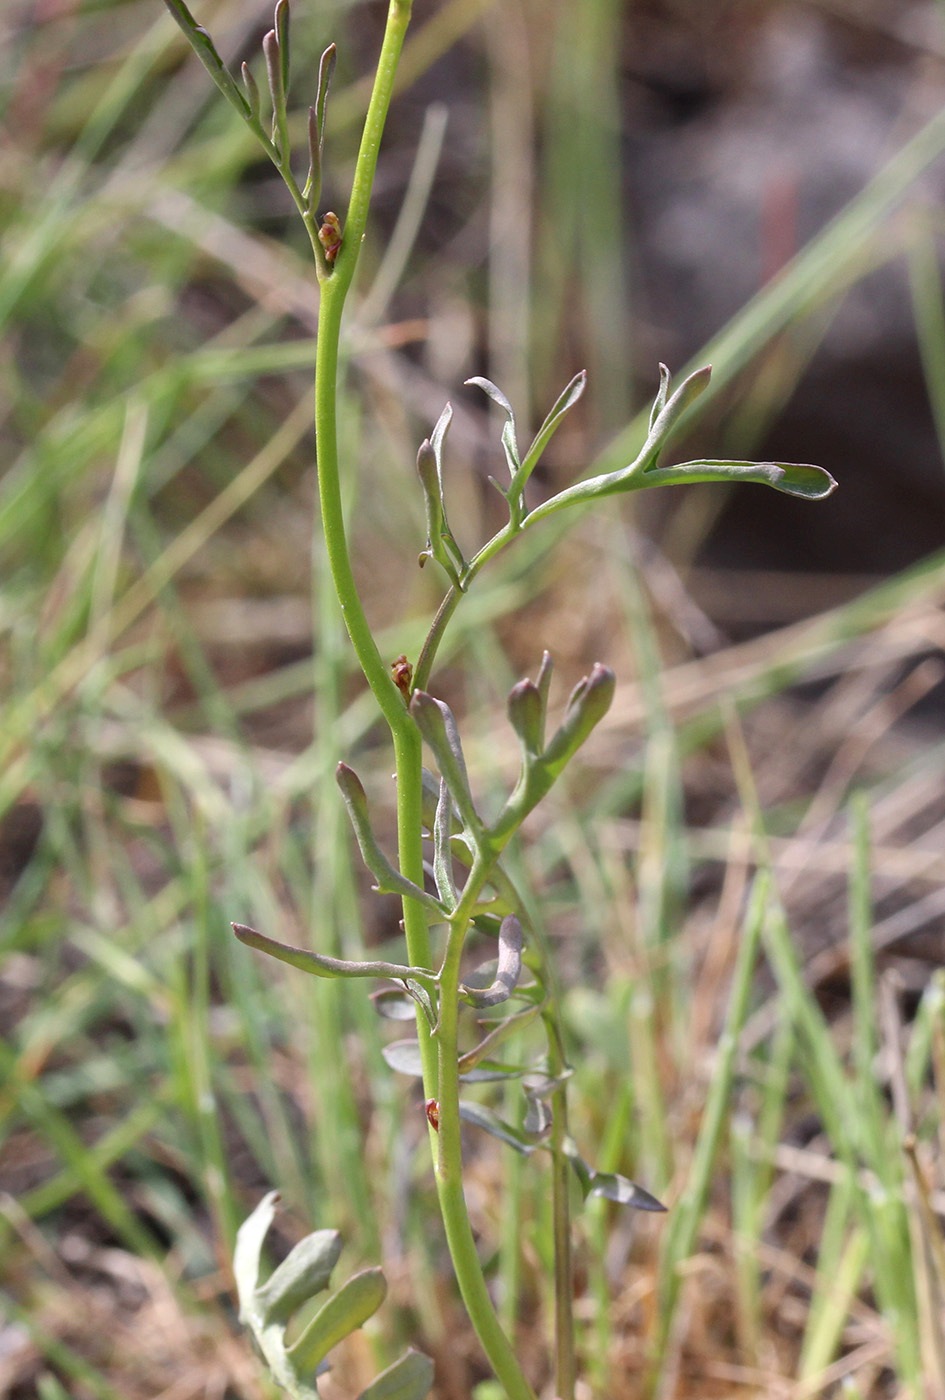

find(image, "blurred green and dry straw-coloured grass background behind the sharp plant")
[0,0,945,1400]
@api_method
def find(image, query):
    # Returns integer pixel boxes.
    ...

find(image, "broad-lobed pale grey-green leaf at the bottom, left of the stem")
[232,1191,433,1400]
